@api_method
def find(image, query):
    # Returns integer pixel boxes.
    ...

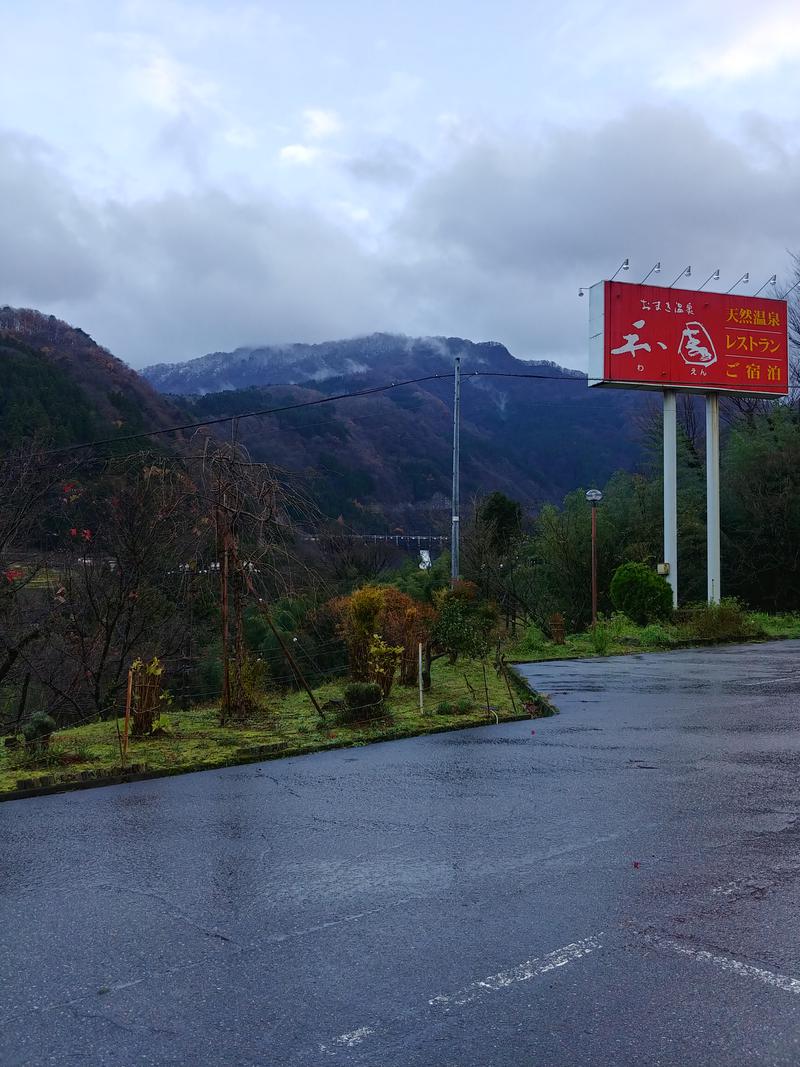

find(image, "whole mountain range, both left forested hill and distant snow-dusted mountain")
[0,307,646,532]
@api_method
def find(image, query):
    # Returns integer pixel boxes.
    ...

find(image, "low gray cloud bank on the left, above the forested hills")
[0,132,401,366]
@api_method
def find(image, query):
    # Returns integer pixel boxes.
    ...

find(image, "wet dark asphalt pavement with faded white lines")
[0,641,800,1067]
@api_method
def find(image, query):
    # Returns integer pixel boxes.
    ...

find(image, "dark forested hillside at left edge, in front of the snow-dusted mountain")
[0,307,179,446]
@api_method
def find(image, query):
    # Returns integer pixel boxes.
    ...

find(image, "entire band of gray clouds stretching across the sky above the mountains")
[0,108,800,366]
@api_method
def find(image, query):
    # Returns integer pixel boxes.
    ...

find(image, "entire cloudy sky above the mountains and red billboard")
[0,0,800,367]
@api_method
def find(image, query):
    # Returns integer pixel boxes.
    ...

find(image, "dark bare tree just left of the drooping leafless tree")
[26,456,196,719]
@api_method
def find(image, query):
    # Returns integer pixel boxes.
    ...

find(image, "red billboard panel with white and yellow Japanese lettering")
[589,282,789,396]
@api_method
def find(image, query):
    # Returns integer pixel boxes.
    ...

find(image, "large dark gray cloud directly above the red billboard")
[404,109,800,272]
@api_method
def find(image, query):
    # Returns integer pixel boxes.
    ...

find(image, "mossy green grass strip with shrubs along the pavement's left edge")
[0,660,554,794]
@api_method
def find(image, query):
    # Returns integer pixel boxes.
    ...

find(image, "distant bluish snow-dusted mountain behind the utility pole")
[154,334,646,522]
